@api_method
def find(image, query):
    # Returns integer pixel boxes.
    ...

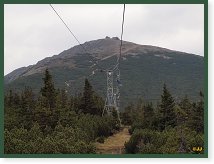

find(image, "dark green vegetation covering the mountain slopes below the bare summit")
[5,50,204,109]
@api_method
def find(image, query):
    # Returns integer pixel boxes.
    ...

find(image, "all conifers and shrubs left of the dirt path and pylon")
[4,70,118,154]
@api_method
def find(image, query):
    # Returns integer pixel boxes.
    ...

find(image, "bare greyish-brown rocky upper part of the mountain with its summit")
[5,36,176,83]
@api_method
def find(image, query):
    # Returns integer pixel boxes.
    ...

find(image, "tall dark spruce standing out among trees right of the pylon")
[159,84,176,130]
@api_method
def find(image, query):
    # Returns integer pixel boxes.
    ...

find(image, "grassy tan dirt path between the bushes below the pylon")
[96,127,130,154]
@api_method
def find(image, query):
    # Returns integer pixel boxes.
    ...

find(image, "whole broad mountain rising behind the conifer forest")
[4,37,204,109]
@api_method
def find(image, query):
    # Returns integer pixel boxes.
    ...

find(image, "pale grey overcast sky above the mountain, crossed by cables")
[4,4,204,75]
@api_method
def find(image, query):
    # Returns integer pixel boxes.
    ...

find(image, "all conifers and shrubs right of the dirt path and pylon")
[121,84,204,154]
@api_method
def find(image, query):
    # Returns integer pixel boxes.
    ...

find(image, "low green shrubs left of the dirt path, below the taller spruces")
[5,112,118,154]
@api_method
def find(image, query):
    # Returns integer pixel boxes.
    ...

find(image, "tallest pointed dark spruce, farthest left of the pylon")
[41,69,56,110]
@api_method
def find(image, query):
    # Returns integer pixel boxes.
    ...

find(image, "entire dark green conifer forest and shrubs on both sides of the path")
[4,69,204,154]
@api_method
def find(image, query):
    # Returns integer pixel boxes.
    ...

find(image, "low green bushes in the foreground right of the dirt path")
[125,126,204,154]
